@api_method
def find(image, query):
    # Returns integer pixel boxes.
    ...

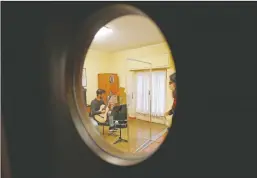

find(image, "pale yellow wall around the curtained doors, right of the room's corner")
[107,43,175,115]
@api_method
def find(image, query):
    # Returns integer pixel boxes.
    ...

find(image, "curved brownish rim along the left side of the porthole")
[66,4,173,166]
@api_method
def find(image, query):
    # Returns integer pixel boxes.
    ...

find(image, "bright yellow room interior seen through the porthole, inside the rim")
[82,16,175,153]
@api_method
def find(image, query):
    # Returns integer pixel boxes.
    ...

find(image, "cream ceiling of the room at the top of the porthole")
[90,15,164,52]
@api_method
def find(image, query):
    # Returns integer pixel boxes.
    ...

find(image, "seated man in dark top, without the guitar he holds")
[90,89,116,131]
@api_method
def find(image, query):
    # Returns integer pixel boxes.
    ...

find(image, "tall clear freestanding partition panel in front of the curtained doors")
[126,59,152,153]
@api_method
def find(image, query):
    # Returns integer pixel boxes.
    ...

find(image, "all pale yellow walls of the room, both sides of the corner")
[85,43,175,124]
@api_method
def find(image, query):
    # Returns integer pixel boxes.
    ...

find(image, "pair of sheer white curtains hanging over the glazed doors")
[136,71,166,117]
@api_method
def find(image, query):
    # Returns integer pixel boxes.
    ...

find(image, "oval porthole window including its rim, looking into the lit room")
[68,5,176,166]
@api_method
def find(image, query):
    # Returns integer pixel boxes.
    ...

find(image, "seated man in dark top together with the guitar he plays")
[90,89,116,131]
